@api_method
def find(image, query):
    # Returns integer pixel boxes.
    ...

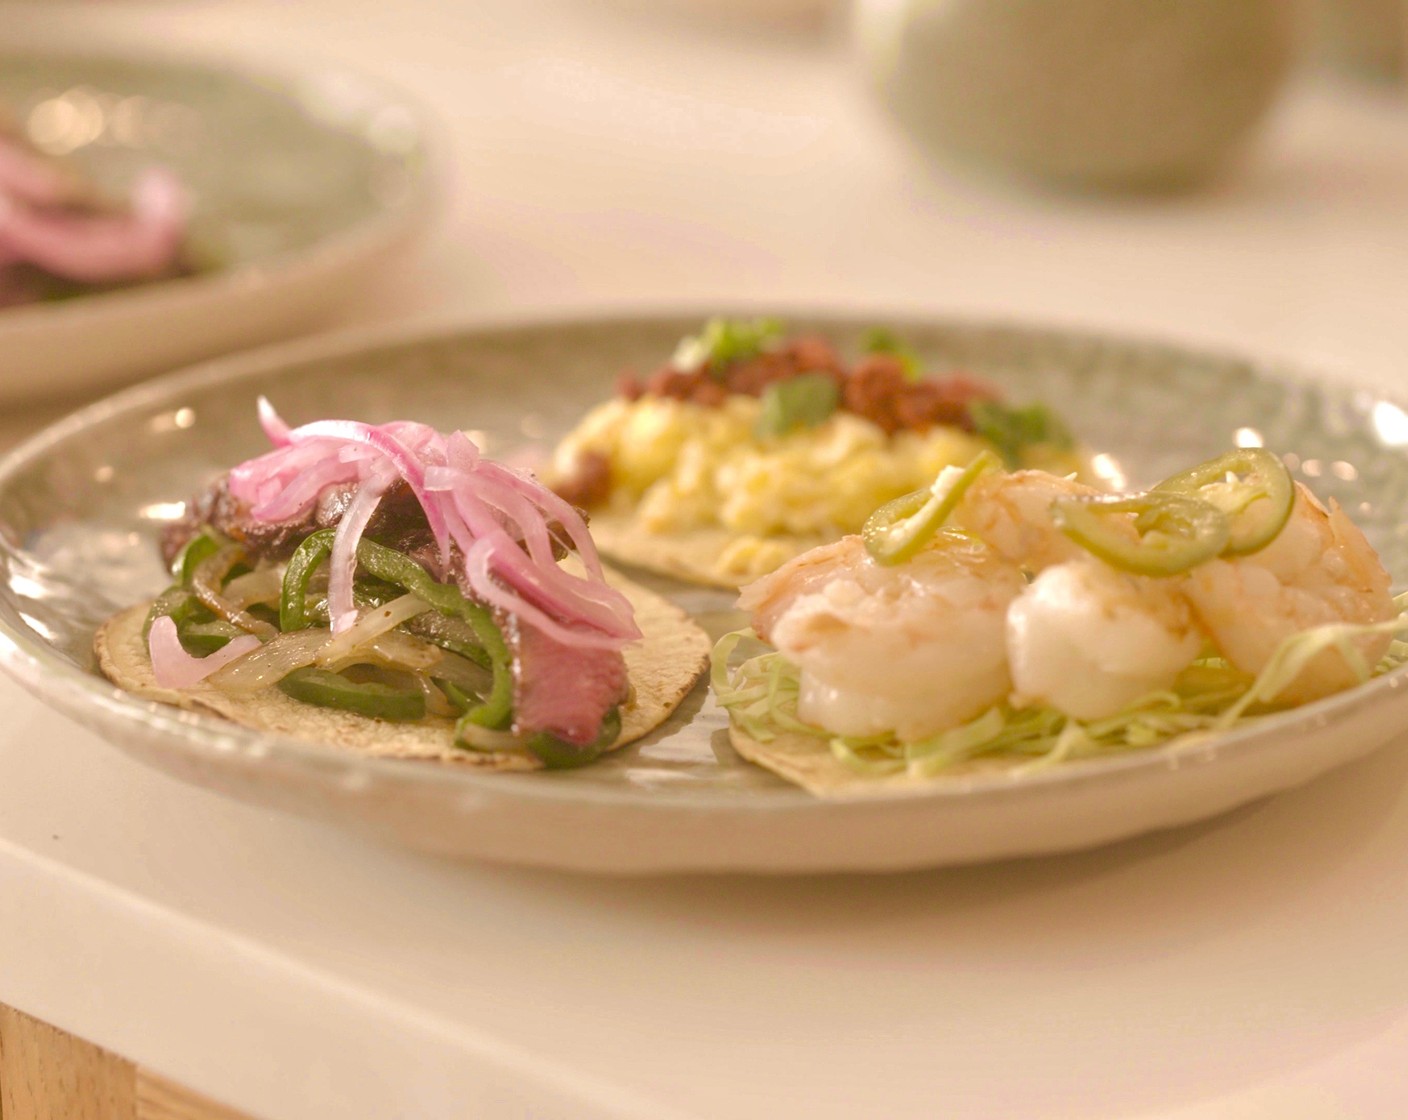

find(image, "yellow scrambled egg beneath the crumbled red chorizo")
[553,396,988,555]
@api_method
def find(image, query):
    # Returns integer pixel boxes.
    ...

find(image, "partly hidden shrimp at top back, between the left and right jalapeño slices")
[952,471,1104,572]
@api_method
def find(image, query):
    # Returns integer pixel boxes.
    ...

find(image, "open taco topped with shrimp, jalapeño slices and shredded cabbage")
[714,448,1408,796]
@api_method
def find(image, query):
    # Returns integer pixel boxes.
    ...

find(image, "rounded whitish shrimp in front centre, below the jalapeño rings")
[1007,556,1204,720]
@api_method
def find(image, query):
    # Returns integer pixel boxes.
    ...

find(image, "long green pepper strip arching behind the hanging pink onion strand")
[279,528,514,728]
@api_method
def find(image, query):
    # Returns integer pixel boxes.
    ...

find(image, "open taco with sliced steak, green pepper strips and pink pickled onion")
[96,400,708,769]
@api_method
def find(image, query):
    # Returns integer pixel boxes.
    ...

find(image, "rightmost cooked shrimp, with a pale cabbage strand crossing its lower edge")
[1183,483,1397,704]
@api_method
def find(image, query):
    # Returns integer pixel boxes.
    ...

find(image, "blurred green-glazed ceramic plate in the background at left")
[0,45,431,402]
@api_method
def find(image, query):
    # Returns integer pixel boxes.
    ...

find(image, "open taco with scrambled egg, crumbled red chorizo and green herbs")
[549,320,1081,587]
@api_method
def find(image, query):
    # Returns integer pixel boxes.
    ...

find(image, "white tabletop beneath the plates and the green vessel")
[0,0,1408,1120]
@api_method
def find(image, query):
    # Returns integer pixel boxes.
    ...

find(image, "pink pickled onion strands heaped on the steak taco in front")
[230,397,641,649]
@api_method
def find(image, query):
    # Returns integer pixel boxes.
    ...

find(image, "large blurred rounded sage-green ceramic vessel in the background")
[853,0,1298,190]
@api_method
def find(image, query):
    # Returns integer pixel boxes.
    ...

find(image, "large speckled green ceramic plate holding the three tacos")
[0,317,1408,872]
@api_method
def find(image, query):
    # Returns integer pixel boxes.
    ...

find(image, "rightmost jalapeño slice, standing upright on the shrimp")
[1153,447,1295,556]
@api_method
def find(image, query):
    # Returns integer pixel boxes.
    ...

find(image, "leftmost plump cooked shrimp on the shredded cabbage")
[739,537,1024,741]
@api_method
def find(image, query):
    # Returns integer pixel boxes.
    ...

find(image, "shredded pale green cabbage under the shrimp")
[710,592,1408,778]
